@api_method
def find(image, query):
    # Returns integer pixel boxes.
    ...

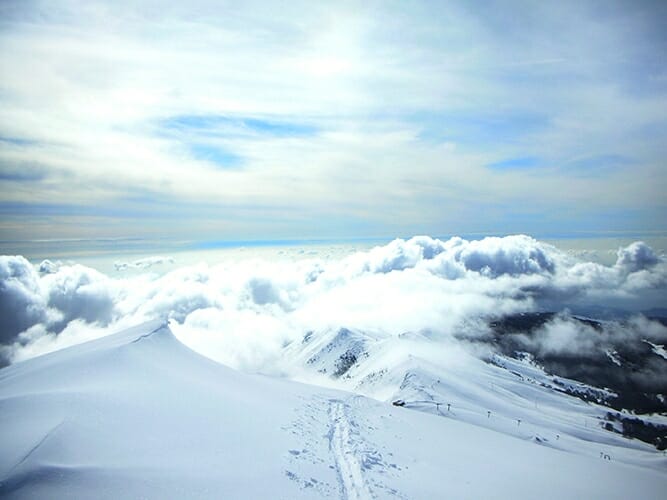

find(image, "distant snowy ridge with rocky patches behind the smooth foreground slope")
[286,328,667,469]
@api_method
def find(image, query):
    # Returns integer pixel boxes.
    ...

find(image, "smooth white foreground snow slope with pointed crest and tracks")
[0,322,667,499]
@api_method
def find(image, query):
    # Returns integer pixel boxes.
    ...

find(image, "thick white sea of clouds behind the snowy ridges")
[0,235,667,372]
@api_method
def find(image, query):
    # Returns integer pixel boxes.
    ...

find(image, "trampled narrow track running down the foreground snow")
[329,400,373,500]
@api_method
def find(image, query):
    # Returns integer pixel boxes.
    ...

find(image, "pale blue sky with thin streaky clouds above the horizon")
[0,0,667,241]
